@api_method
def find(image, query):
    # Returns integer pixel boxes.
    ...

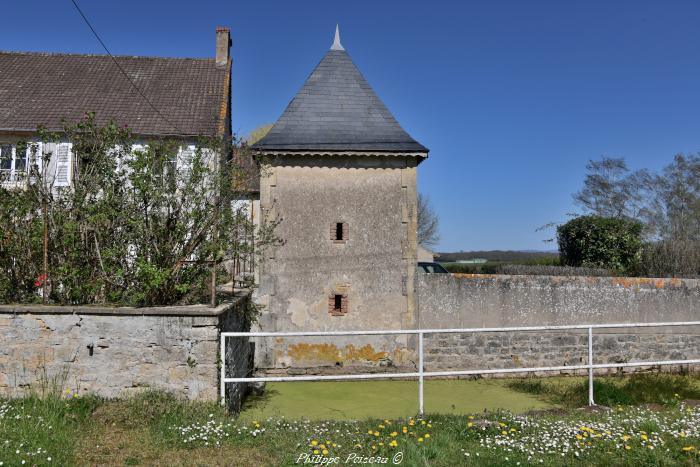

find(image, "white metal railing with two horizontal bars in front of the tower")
[219,321,700,414]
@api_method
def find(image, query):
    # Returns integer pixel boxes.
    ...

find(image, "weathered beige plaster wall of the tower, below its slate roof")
[256,155,416,367]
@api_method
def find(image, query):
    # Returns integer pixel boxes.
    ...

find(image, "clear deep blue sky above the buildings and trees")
[5,0,700,251]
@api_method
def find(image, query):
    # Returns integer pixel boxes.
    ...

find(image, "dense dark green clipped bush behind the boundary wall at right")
[557,216,642,272]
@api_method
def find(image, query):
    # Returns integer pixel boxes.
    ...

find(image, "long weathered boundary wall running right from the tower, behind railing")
[416,274,700,371]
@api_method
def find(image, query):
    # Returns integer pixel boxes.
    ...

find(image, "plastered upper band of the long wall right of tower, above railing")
[417,274,700,328]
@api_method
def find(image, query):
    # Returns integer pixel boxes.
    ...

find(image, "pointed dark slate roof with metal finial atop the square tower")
[253,31,428,153]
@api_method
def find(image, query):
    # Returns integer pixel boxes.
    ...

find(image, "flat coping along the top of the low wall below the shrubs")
[0,291,250,316]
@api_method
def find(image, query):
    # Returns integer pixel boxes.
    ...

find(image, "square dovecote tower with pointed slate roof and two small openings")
[254,27,428,367]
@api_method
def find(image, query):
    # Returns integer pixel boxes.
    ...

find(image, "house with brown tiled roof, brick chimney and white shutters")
[0,28,231,191]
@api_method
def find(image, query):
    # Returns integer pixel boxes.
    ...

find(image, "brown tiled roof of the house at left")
[0,52,230,136]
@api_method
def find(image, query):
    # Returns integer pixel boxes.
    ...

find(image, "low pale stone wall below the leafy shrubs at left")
[0,296,250,406]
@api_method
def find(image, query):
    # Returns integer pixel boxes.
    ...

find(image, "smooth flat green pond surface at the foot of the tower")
[241,379,556,420]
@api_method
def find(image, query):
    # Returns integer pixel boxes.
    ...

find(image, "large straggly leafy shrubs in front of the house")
[0,116,275,306]
